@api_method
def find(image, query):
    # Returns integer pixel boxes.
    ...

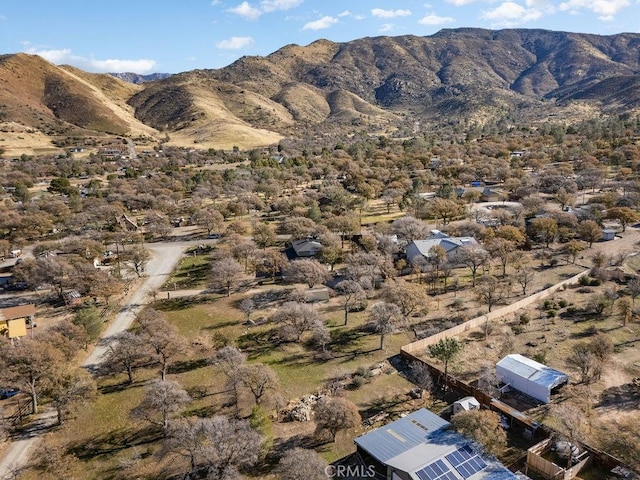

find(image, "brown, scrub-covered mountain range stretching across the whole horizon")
[0,28,640,152]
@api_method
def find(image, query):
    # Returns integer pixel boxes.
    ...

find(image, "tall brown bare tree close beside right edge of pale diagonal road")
[136,308,187,380]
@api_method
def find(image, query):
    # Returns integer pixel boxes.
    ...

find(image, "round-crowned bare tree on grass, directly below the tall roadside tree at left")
[131,380,191,437]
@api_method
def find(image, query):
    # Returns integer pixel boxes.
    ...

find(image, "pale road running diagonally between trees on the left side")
[0,240,192,480]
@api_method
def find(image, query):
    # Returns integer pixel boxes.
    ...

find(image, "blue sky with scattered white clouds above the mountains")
[0,0,640,73]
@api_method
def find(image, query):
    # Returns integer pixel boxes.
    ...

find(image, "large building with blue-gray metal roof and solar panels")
[355,408,526,480]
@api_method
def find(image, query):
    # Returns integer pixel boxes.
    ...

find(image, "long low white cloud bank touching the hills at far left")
[27,48,158,74]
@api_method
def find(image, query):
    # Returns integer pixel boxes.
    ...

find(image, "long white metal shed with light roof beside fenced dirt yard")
[496,353,569,403]
